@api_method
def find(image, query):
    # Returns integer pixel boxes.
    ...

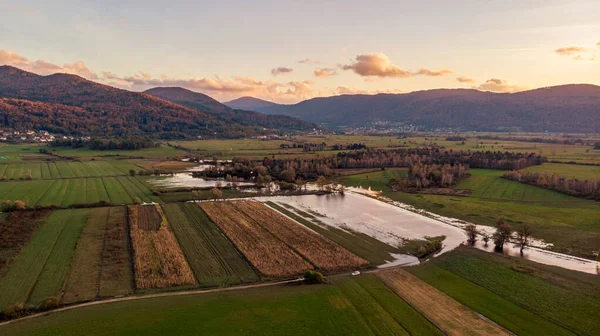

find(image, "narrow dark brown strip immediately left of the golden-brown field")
[98,207,133,297]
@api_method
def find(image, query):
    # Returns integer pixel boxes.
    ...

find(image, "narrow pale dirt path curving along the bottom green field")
[0,278,304,327]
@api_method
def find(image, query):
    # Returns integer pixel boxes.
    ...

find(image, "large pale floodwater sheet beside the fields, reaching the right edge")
[258,189,600,274]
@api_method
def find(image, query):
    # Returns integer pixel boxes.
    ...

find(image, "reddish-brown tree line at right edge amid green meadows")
[502,170,600,201]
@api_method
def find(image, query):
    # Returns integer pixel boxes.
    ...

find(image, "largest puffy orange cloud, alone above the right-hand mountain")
[341,53,412,78]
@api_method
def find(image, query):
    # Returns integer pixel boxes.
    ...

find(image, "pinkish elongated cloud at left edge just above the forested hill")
[0,50,98,79]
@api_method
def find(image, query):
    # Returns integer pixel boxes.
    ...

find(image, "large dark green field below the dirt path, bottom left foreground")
[0,275,441,336]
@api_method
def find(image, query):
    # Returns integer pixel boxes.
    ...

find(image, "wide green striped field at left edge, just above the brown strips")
[0,176,160,207]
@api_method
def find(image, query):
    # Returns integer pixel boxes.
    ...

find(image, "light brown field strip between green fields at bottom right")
[377,269,510,335]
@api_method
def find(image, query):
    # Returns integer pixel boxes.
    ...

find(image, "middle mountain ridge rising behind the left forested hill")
[144,87,316,130]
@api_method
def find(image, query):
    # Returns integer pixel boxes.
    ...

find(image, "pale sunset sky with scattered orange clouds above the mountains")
[0,0,600,103]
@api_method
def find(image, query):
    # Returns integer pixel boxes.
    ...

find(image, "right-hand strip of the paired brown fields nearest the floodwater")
[236,201,369,272]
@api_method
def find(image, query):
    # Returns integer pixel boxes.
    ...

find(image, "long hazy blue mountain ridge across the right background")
[258,84,600,132]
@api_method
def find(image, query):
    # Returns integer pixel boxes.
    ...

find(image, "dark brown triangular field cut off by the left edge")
[0,210,50,278]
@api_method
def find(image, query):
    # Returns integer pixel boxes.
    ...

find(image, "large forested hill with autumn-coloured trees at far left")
[0,66,310,138]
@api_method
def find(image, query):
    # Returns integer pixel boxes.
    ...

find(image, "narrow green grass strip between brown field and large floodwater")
[266,201,400,266]
